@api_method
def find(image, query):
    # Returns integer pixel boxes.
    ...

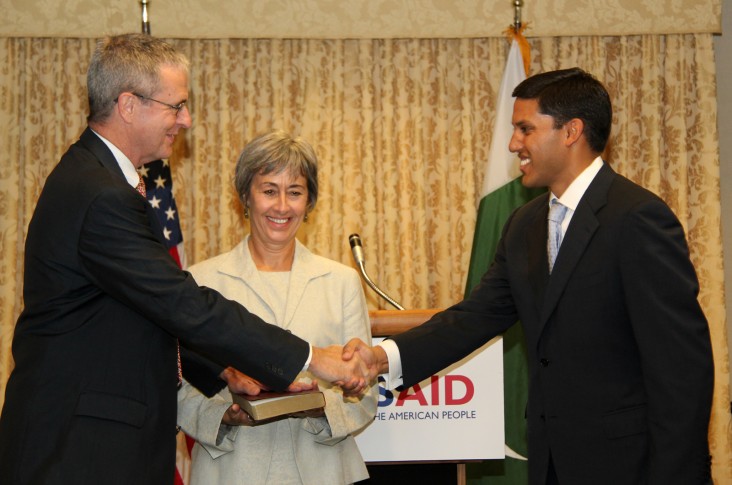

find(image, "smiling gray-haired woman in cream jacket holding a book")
[178,131,378,485]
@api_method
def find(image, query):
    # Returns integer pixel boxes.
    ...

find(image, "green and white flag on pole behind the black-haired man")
[465,28,544,485]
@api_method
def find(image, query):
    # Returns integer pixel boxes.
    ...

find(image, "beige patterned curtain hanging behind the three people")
[0,34,732,483]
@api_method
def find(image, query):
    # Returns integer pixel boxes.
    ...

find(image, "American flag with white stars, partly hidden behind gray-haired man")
[138,160,194,485]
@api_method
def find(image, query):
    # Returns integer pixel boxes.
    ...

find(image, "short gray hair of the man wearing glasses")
[86,34,189,122]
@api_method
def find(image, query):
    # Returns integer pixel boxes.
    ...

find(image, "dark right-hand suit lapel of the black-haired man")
[540,164,615,330]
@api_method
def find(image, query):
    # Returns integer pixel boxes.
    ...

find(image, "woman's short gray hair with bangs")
[234,130,318,212]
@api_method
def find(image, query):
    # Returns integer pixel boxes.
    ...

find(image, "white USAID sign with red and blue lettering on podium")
[356,337,505,462]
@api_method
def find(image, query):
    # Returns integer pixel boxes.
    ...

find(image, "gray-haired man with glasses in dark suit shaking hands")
[0,35,363,485]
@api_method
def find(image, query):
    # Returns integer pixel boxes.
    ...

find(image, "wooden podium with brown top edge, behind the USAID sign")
[365,308,467,485]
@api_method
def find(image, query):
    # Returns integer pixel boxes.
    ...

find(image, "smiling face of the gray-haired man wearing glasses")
[130,66,191,168]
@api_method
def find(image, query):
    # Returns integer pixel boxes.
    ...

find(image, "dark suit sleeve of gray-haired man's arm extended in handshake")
[78,184,309,389]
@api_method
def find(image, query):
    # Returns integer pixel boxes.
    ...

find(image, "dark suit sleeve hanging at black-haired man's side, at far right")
[620,196,714,483]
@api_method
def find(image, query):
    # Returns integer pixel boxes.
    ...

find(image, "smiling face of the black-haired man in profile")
[508,98,574,197]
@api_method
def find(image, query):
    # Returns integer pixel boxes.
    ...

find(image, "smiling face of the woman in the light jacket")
[247,170,308,248]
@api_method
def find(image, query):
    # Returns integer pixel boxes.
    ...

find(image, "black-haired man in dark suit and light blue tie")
[344,69,714,485]
